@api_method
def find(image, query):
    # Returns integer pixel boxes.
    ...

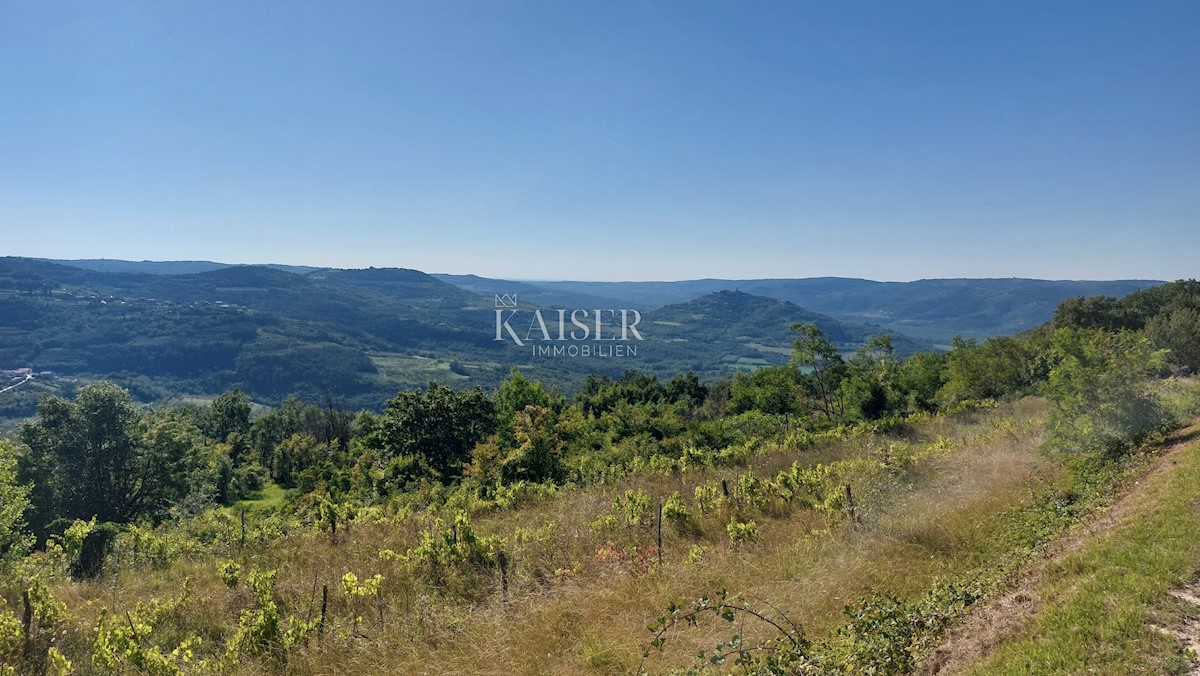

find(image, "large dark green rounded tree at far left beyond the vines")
[20,382,200,534]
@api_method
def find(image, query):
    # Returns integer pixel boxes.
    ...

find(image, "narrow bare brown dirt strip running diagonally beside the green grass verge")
[918,424,1200,676]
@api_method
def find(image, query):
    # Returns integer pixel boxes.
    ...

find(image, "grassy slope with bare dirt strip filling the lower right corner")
[924,424,1200,675]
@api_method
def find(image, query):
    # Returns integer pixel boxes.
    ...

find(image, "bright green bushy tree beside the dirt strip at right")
[1046,329,1171,456]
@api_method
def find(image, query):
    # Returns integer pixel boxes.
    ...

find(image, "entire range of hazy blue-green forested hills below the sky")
[0,257,1156,418]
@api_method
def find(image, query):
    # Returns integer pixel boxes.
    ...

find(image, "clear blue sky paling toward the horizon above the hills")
[0,0,1200,280]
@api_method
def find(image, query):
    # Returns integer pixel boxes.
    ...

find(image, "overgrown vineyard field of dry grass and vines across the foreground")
[5,389,1200,674]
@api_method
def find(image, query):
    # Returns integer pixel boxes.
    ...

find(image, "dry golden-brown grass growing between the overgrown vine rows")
[18,400,1054,676]
